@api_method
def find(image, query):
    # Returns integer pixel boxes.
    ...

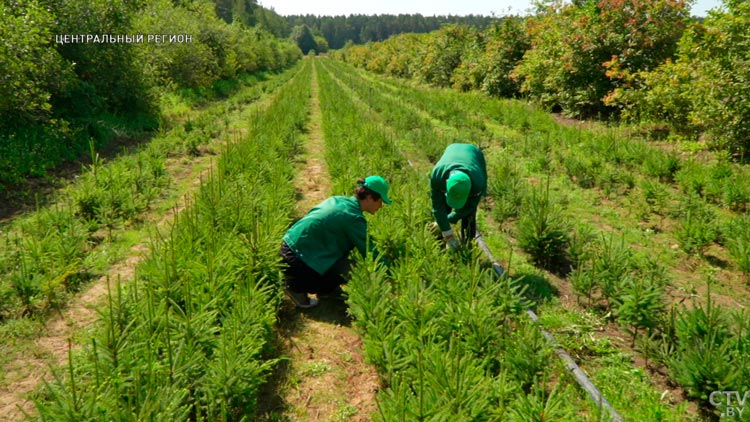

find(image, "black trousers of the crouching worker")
[279,241,351,294]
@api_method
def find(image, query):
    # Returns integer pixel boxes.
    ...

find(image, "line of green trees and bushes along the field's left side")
[0,0,301,192]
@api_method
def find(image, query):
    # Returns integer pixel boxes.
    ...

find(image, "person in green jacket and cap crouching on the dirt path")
[279,176,391,308]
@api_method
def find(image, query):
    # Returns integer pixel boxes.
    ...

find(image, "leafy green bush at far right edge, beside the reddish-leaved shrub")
[619,2,750,158]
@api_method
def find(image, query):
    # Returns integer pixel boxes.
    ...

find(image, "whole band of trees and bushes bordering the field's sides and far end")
[0,0,750,192]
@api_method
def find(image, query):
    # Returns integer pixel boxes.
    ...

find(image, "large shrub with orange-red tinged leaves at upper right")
[514,0,688,116]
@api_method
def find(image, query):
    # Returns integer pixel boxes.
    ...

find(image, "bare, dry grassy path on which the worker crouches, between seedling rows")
[265,56,379,421]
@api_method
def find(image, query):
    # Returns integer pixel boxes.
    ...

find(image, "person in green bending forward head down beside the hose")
[430,144,487,249]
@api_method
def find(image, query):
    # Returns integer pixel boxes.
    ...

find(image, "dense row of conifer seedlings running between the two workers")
[313,58,592,421]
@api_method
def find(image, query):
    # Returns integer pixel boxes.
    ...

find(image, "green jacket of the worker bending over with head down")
[430,144,487,231]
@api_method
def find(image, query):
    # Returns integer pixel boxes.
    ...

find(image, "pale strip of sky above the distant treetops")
[258,0,721,16]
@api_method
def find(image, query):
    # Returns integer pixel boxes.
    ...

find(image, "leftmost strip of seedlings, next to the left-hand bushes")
[0,65,288,326]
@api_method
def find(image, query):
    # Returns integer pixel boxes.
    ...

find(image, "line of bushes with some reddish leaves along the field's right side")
[336,0,750,159]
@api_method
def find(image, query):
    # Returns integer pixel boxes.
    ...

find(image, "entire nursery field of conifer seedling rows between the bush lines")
[0,57,750,421]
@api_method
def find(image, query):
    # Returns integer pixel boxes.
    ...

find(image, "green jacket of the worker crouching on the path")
[284,196,377,275]
